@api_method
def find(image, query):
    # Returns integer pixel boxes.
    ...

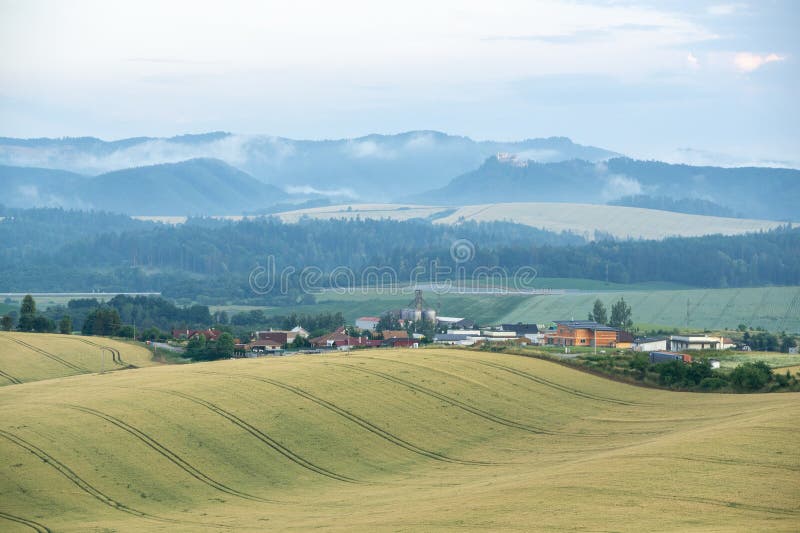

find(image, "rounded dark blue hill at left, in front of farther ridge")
[0,159,287,215]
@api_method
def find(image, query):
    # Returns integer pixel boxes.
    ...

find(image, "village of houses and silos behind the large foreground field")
[172,290,747,368]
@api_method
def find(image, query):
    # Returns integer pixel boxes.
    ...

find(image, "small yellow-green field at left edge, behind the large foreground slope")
[0,332,160,385]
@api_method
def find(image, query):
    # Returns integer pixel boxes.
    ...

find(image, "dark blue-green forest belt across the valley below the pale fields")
[0,209,800,303]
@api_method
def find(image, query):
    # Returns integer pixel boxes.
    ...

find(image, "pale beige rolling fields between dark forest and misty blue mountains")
[276,202,784,240]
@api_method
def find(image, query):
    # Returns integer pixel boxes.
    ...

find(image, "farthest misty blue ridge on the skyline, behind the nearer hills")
[0,131,619,201]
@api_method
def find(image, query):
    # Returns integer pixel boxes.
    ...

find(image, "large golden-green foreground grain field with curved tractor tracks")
[0,350,800,531]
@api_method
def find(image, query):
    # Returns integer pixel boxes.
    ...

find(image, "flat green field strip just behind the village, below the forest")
[214,282,800,333]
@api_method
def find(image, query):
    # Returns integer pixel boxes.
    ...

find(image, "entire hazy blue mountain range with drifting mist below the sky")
[0,131,800,220]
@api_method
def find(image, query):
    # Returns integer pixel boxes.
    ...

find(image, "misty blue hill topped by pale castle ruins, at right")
[418,157,800,220]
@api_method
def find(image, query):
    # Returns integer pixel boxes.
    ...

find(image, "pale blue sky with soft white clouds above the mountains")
[0,0,800,168]
